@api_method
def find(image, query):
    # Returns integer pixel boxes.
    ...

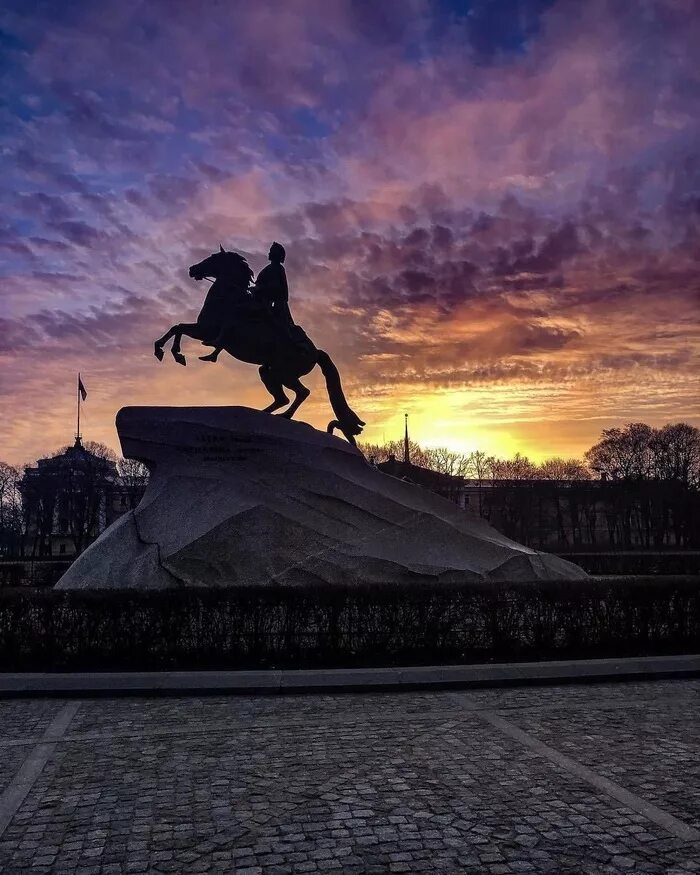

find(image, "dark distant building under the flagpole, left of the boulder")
[20,437,145,558]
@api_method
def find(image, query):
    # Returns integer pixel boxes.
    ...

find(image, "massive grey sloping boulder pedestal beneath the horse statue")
[58,407,586,589]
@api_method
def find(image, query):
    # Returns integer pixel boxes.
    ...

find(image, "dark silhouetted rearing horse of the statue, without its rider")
[154,246,365,445]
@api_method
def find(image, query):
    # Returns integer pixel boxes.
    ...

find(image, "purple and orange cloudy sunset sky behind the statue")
[0,0,700,463]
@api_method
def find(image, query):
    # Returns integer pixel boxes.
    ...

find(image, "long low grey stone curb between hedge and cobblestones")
[0,654,700,698]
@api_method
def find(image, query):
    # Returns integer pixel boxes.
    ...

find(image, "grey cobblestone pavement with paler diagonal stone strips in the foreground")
[0,681,700,875]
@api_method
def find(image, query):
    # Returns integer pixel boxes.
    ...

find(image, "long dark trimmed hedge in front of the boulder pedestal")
[0,576,700,671]
